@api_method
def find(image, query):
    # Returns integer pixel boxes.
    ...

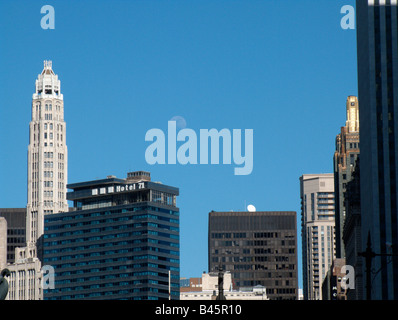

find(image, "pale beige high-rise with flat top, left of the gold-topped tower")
[300,173,336,300]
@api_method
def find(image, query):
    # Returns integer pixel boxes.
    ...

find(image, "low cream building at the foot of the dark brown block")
[180,272,269,300]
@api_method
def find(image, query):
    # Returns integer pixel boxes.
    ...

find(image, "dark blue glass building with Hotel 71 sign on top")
[42,172,180,300]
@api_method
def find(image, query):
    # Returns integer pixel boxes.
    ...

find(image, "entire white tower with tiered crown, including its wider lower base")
[7,61,68,300]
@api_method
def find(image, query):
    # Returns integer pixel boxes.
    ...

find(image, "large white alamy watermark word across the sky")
[145,121,253,175]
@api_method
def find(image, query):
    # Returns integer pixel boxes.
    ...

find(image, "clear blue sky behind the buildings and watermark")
[0,0,357,286]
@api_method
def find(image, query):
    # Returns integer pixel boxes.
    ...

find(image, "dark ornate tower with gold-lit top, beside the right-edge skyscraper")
[333,96,359,258]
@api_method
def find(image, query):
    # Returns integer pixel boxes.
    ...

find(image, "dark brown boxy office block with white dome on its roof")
[208,211,298,300]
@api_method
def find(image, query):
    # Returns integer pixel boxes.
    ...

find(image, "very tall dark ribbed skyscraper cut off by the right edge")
[356,0,398,300]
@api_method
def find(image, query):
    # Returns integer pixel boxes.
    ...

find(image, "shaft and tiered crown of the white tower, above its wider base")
[26,61,68,243]
